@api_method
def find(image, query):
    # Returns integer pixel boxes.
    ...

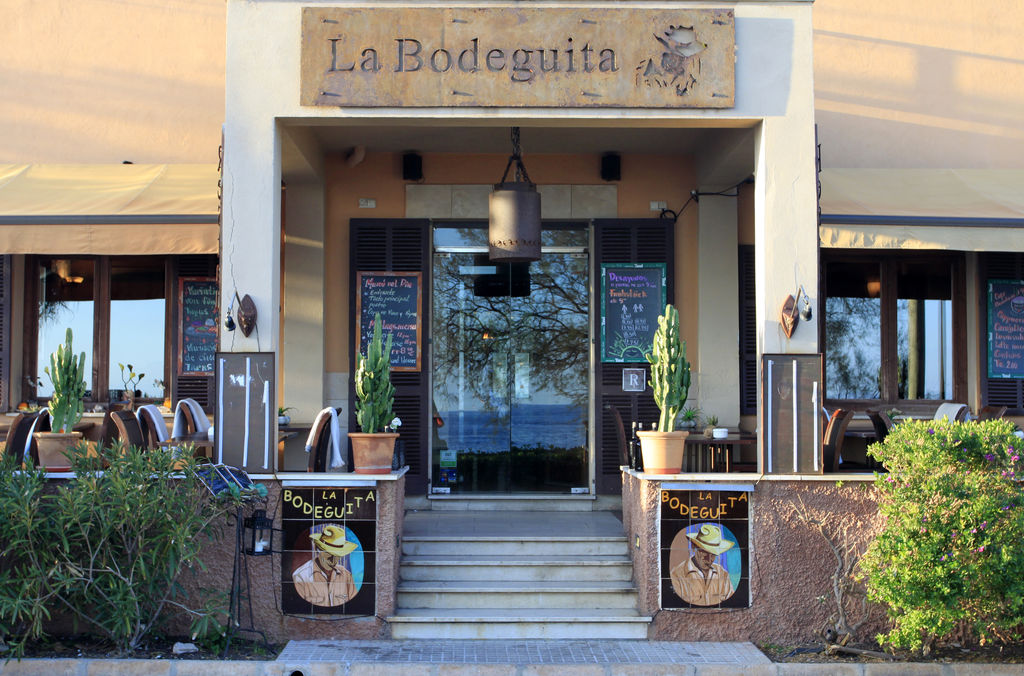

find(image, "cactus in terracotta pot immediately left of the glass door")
[348,312,398,474]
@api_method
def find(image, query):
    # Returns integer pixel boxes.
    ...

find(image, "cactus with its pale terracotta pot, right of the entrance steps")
[637,305,690,474]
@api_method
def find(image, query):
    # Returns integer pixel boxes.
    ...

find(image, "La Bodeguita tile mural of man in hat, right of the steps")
[660,490,751,609]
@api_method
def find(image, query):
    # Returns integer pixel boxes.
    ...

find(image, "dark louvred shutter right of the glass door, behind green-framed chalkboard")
[592,219,675,495]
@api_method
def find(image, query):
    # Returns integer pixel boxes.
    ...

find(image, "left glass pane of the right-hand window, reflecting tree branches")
[825,297,882,399]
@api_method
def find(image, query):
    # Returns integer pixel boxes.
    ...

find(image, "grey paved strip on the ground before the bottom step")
[278,639,771,665]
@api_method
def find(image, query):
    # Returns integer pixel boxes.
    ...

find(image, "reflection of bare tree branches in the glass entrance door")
[432,250,589,417]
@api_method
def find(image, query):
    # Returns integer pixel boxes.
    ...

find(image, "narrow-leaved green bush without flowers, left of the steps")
[0,446,234,654]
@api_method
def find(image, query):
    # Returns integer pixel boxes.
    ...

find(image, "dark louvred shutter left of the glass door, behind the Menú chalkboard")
[348,219,431,495]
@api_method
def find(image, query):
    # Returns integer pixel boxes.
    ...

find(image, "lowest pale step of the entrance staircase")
[387,608,651,639]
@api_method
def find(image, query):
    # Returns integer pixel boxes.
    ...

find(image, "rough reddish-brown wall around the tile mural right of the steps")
[623,473,885,643]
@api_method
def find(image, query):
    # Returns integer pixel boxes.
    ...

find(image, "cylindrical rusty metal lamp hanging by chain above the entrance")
[487,127,541,262]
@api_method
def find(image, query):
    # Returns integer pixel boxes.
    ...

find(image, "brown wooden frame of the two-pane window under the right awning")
[818,250,968,417]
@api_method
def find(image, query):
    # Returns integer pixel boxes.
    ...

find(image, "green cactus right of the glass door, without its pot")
[644,305,690,432]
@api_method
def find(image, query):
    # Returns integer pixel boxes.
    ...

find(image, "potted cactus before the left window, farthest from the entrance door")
[34,329,85,471]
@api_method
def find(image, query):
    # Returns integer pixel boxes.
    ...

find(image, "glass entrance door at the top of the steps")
[431,224,590,494]
